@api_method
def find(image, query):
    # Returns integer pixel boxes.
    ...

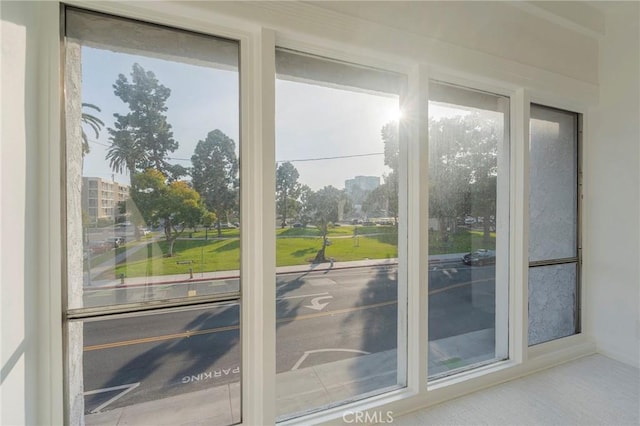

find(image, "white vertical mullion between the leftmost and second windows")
[240,29,276,425]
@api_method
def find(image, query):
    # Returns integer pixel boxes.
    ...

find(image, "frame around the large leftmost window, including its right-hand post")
[59,2,275,424]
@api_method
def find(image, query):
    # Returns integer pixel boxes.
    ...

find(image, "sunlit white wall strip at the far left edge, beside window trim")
[0,4,36,425]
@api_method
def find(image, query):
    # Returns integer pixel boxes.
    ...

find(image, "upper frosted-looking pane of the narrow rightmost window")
[529,105,578,261]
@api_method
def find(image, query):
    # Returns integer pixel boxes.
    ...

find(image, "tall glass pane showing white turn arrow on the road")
[275,51,406,419]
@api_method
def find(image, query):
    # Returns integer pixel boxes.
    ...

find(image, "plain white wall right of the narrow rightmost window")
[584,2,640,366]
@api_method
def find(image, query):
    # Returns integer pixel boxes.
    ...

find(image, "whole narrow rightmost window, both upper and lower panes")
[529,105,580,345]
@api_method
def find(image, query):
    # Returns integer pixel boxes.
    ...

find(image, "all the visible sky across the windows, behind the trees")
[82,46,459,190]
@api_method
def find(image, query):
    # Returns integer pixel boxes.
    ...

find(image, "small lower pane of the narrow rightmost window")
[529,263,577,345]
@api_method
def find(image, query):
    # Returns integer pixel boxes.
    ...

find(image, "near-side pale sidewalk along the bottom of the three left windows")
[85,330,493,426]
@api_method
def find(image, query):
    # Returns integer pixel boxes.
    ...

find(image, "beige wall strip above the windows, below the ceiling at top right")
[312,1,598,83]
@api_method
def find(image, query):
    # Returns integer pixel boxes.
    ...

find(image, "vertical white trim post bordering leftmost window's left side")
[40,2,65,424]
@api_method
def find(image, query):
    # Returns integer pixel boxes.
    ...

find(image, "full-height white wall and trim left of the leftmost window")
[0,1,62,425]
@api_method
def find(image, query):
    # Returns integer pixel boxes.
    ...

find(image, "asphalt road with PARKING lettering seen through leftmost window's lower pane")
[83,305,241,413]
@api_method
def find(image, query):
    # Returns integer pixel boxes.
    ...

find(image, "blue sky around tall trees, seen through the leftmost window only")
[82,47,239,183]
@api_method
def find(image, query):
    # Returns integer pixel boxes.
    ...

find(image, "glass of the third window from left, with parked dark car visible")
[428,82,509,377]
